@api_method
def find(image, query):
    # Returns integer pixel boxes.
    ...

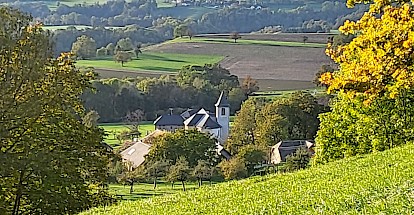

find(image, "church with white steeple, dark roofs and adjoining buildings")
[154,92,230,145]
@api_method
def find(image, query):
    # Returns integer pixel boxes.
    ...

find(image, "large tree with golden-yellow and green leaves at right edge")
[314,0,414,162]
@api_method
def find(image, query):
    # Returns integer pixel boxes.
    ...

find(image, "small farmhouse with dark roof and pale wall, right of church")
[269,140,315,164]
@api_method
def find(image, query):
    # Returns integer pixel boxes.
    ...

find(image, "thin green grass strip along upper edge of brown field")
[166,37,326,48]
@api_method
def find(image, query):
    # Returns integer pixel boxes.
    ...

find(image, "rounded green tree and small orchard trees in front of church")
[113,129,222,192]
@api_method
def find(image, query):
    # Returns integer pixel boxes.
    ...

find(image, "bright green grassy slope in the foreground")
[83,144,414,215]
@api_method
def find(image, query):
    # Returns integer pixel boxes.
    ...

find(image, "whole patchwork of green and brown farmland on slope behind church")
[85,33,332,91]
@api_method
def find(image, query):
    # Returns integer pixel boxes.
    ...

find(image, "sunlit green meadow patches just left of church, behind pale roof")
[99,121,155,148]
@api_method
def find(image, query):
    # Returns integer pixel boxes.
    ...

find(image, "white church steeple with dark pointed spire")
[215,92,230,144]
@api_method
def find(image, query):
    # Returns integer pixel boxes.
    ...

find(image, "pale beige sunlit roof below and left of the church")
[121,141,150,167]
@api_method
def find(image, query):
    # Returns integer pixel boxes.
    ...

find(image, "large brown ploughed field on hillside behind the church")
[147,34,331,91]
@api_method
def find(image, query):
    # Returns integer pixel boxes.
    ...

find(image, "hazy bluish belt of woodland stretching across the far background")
[3,0,367,54]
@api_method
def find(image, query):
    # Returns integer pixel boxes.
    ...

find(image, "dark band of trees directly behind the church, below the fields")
[82,64,258,122]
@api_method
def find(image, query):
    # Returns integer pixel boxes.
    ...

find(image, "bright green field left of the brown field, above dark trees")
[76,51,224,74]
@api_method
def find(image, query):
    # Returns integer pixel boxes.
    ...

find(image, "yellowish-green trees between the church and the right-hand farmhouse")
[206,92,327,179]
